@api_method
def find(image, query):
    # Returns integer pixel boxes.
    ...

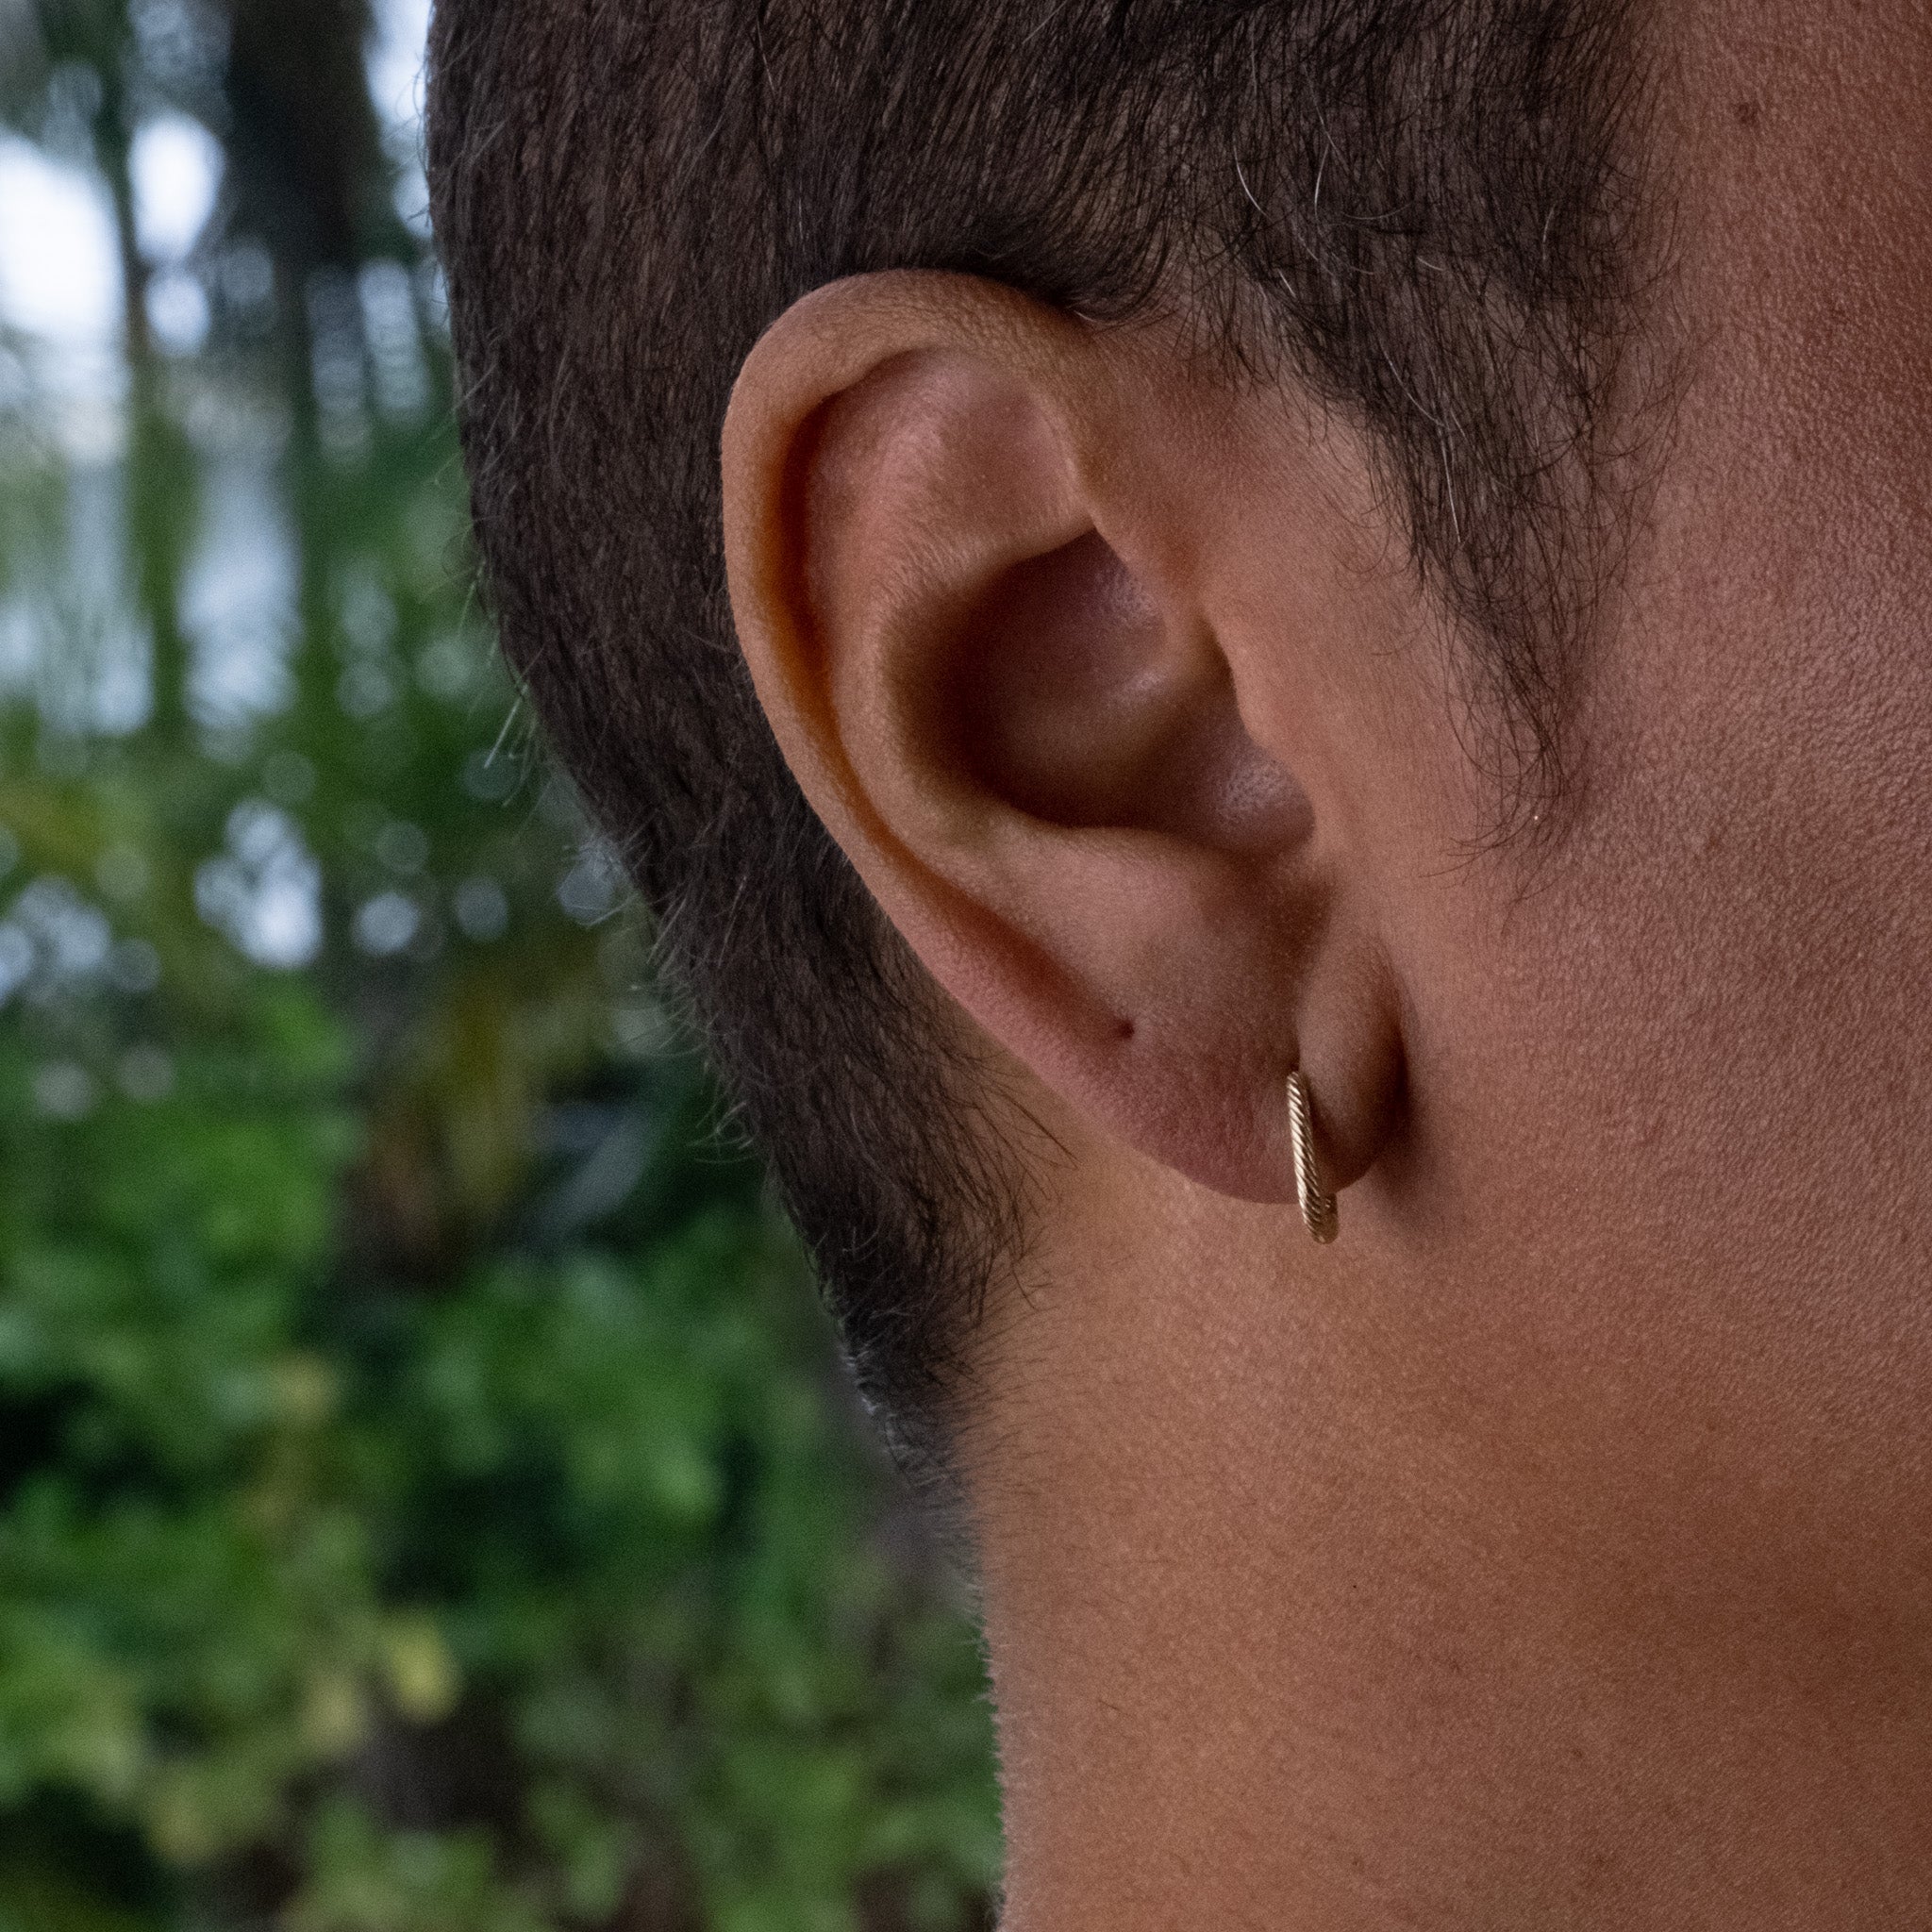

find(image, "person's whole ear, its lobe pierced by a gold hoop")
[724,275,1401,1202]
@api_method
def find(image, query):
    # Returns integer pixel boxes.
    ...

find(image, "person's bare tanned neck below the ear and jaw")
[972,1166,1932,1932]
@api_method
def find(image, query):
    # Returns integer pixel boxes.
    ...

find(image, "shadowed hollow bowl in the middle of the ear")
[931,531,1307,852]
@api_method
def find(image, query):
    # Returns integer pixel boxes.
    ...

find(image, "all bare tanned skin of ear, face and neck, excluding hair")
[724,0,1932,1932]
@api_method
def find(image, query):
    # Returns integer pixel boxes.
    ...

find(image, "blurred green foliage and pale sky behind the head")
[0,0,999,1932]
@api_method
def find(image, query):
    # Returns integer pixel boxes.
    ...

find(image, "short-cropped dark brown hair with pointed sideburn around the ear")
[429,0,1644,1453]
